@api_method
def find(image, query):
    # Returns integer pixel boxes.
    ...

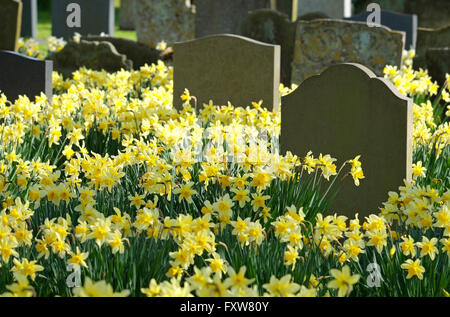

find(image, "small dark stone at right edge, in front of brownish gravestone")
[426,47,450,85]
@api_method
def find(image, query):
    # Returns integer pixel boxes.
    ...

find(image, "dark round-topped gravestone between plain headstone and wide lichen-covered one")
[242,9,296,86]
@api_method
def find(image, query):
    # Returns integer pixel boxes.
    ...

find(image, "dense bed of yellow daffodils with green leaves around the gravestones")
[0,52,450,297]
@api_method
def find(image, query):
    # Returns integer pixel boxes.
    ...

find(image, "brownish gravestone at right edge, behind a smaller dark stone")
[414,25,450,69]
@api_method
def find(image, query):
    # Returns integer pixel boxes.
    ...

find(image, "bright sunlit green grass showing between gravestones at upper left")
[38,0,137,52]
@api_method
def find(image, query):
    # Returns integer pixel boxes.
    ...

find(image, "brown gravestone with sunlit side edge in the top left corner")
[0,0,22,51]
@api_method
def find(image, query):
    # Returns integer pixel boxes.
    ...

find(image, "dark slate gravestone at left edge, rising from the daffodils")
[0,51,53,102]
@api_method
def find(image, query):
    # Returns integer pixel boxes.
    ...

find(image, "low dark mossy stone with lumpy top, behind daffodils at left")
[49,40,133,78]
